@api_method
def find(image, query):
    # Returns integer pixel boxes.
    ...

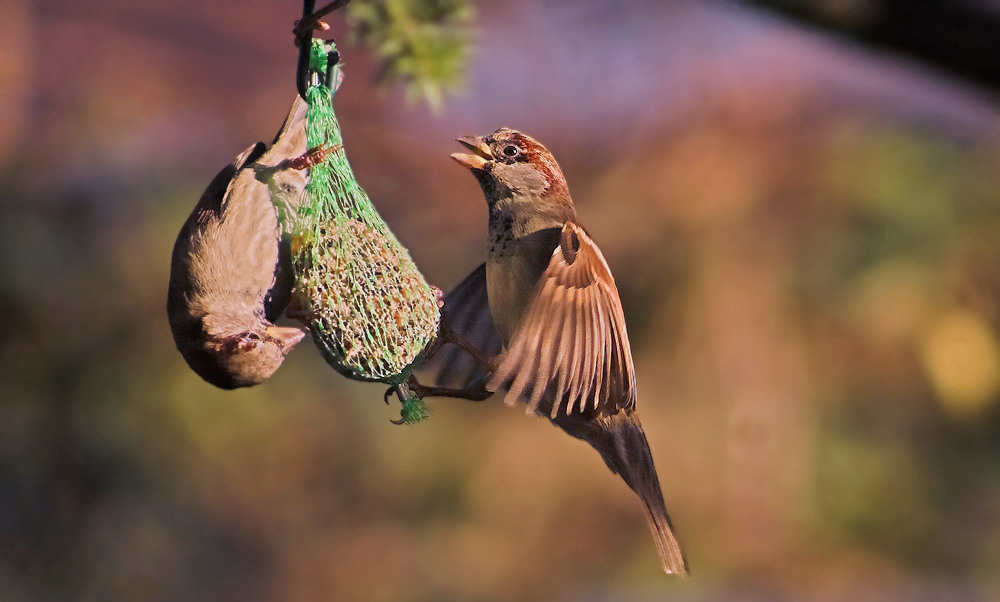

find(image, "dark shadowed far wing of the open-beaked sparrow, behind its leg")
[418,263,501,388]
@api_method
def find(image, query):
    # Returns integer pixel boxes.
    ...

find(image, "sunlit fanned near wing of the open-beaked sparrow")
[487,222,635,418]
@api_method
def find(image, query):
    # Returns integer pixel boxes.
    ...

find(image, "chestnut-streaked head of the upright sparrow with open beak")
[451,128,569,205]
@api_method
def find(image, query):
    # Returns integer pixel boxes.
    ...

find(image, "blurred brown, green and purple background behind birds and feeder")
[0,0,1000,601]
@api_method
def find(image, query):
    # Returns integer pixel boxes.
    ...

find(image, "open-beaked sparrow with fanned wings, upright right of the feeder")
[446,128,687,574]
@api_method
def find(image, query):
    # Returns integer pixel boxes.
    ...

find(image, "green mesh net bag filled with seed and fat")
[289,40,440,422]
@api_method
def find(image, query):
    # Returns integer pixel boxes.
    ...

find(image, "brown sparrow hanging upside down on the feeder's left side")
[167,96,326,389]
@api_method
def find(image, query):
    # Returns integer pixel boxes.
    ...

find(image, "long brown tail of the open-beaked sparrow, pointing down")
[554,411,687,575]
